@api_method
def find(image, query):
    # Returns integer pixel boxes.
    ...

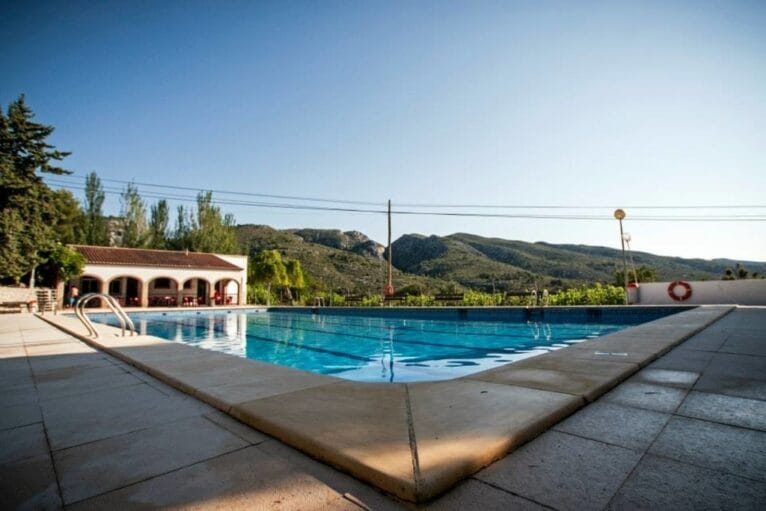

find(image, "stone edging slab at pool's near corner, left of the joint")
[232,382,417,500]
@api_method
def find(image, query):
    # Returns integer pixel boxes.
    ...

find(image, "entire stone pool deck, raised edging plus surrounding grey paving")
[0,307,766,509]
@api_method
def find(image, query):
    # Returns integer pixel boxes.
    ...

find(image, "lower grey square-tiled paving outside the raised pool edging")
[0,308,766,510]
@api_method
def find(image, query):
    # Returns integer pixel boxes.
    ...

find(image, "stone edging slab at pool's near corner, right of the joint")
[408,380,584,500]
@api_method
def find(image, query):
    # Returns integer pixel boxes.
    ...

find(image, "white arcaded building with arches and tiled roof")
[64,245,247,307]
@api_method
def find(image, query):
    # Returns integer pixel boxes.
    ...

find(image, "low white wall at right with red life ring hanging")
[637,279,766,305]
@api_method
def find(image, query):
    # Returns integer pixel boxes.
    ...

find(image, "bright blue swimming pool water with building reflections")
[91,308,678,382]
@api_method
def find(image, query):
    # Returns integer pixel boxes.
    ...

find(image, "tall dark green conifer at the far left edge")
[0,95,70,282]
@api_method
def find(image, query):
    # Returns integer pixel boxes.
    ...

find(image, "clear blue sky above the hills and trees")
[0,0,766,261]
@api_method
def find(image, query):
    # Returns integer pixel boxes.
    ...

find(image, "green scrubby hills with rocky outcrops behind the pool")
[237,224,766,294]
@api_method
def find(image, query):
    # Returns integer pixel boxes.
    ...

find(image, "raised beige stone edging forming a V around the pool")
[34,307,733,502]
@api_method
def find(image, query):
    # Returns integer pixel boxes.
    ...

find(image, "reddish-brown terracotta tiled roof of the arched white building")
[71,245,242,271]
